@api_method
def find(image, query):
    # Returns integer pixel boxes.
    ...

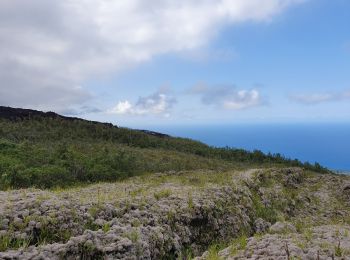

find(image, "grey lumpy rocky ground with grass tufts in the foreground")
[0,168,350,259]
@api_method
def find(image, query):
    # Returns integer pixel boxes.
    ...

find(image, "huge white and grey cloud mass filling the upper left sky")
[0,0,303,110]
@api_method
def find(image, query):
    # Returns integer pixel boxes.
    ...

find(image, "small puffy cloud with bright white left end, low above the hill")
[107,91,176,117]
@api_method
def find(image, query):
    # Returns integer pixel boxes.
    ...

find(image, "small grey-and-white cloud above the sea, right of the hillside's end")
[187,85,263,110]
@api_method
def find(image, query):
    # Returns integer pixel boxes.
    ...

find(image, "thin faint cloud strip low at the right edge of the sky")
[289,90,350,105]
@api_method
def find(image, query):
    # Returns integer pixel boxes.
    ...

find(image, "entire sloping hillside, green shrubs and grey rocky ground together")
[0,107,350,260]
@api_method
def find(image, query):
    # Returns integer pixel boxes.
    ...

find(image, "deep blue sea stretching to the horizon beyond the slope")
[152,124,350,173]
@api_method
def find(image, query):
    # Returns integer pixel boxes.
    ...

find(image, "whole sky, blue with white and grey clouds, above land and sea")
[0,0,350,127]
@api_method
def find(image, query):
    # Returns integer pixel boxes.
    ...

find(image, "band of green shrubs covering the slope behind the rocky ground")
[0,108,328,190]
